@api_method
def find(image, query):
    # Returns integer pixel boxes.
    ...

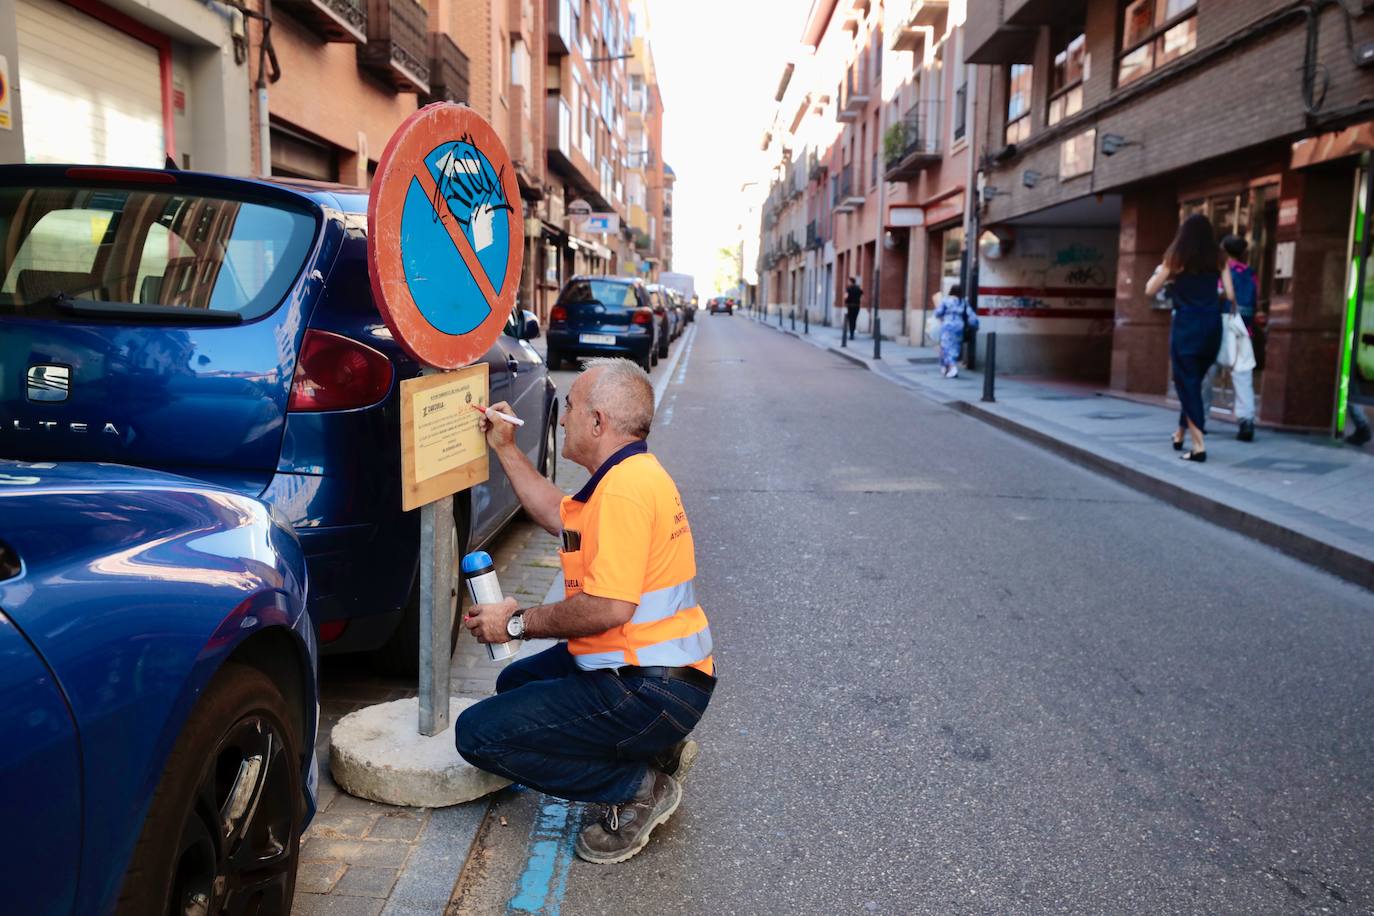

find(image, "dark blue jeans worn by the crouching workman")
[453,643,710,805]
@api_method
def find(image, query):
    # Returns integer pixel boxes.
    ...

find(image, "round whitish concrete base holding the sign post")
[330,696,510,808]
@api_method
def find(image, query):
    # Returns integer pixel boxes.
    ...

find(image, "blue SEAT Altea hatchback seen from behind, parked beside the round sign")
[0,165,558,673]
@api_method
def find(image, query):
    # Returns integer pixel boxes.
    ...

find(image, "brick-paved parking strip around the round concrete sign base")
[293,439,587,916]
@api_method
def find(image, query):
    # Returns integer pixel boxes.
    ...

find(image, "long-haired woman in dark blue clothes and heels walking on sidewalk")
[1145,213,1235,461]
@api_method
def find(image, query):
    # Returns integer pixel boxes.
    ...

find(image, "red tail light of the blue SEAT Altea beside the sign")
[287,328,393,411]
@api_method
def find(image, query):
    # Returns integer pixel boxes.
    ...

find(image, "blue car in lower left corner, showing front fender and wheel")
[0,461,317,916]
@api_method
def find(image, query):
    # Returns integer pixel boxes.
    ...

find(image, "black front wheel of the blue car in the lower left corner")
[116,662,309,916]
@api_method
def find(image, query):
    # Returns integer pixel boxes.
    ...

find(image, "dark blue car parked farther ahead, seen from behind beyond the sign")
[548,276,656,372]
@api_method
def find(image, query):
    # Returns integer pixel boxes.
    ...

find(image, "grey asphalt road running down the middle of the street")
[453,314,1374,916]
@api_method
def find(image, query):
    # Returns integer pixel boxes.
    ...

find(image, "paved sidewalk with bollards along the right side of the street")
[768,316,1374,589]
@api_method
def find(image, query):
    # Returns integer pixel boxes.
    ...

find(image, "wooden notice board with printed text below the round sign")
[401,363,491,511]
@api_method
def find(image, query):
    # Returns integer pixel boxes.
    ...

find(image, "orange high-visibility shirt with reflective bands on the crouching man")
[559,441,714,674]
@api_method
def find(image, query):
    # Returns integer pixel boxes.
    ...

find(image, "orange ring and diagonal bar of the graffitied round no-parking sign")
[367,102,525,369]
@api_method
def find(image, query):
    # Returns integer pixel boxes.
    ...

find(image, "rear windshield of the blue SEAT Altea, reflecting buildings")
[0,185,316,320]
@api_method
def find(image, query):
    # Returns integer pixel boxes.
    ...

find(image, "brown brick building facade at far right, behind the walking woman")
[967,0,1374,427]
